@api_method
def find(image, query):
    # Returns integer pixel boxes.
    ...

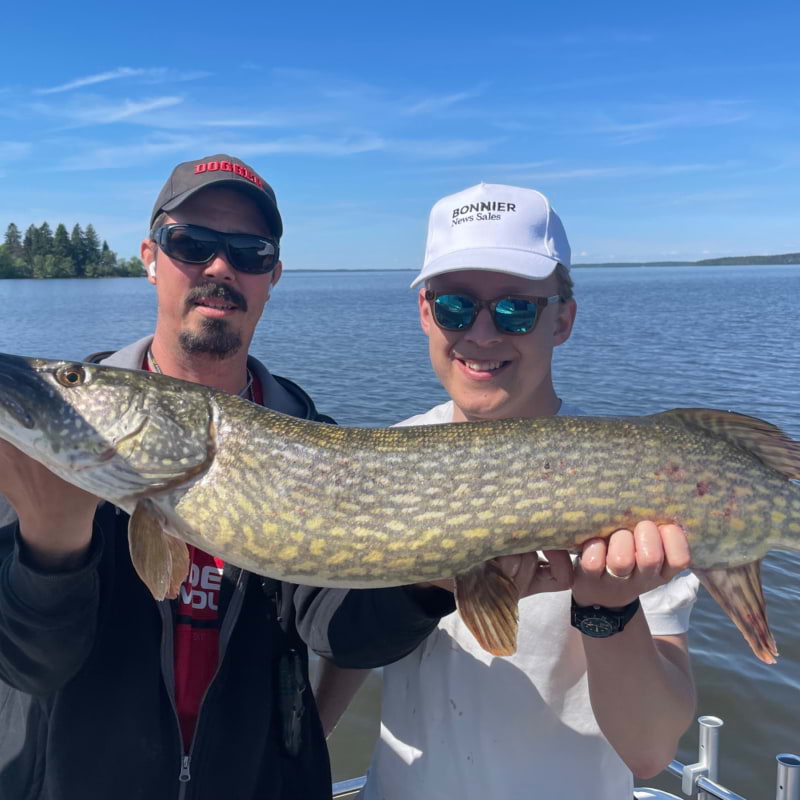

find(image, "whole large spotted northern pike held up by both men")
[0,355,800,663]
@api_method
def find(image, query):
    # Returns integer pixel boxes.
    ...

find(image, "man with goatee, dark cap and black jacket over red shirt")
[0,155,453,800]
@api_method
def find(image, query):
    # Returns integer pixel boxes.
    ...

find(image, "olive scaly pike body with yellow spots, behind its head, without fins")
[167,398,800,586]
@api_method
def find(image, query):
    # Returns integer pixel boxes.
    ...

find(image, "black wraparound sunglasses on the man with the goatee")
[152,223,279,275]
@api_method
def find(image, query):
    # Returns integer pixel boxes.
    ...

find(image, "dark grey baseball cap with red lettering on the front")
[150,153,283,239]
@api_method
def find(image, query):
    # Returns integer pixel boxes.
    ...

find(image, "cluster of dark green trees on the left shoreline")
[0,222,144,278]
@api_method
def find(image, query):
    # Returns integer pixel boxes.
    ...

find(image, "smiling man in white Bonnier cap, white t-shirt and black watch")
[323,184,697,800]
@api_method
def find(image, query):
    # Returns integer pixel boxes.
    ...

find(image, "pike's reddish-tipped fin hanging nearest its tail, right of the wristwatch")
[693,560,778,664]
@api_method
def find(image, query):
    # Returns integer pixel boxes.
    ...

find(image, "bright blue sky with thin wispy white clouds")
[0,0,800,269]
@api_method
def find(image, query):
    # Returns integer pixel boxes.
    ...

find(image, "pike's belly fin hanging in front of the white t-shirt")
[455,561,519,656]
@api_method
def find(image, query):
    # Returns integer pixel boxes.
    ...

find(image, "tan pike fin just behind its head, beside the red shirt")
[128,500,189,600]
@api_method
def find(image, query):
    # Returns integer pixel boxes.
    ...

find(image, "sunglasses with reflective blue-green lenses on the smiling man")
[425,289,564,336]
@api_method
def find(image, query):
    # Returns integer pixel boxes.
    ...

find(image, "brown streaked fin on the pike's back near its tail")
[653,408,800,480]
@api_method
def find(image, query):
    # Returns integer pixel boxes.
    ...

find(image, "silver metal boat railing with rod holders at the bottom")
[333,716,800,800]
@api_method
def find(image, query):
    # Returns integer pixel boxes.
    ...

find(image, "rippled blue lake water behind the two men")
[0,266,800,800]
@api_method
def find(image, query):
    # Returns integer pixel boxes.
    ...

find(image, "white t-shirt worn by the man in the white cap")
[361,402,698,800]
